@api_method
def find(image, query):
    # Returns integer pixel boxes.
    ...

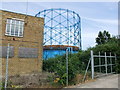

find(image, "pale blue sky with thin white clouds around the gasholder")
[0,2,118,50]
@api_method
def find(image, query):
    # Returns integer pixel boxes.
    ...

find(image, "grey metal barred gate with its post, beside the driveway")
[90,50,117,79]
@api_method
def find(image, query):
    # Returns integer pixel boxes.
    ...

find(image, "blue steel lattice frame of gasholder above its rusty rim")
[36,8,81,48]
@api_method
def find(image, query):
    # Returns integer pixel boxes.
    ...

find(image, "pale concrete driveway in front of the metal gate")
[72,74,118,88]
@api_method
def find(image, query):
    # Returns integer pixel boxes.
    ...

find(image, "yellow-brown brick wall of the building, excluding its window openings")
[0,11,44,76]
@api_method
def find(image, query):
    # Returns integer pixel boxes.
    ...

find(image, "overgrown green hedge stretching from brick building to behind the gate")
[43,31,120,86]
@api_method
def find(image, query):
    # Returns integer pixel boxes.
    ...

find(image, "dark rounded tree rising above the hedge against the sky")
[96,30,111,45]
